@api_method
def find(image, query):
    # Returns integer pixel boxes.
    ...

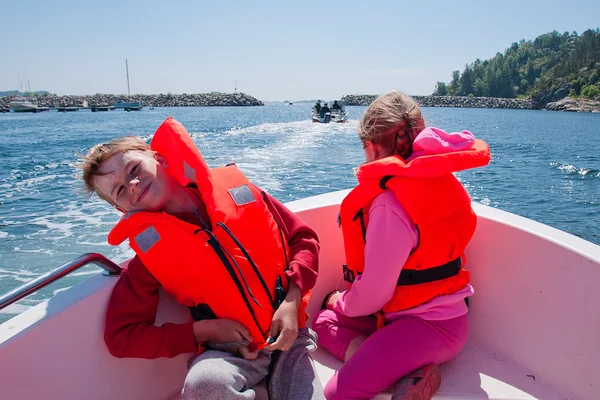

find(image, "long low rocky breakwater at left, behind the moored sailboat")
[0,92,264,108]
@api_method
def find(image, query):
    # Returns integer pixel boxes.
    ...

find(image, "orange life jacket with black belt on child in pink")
[340,140,490,318]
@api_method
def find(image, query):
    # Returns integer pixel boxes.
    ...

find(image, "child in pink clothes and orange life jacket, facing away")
[313,92,490,400]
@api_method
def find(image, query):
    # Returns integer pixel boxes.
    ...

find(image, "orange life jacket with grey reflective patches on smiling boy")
[108,117,307,348]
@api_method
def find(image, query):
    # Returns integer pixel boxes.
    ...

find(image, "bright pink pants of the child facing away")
[313,310,469,400]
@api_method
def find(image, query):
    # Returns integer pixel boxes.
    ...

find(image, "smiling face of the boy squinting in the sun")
[93,150,174,212]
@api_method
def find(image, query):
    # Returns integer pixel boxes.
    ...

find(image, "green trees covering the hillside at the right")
[433,28,600,103]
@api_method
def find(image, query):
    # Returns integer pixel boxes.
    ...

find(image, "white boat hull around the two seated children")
[0,191,600,400]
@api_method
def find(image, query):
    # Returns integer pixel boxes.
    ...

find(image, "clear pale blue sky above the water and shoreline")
[0,0,600,101]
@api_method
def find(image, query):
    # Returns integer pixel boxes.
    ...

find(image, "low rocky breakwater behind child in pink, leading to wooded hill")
[341,95,536,109]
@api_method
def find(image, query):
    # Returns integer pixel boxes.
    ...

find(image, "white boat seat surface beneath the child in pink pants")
[313,346,564,400]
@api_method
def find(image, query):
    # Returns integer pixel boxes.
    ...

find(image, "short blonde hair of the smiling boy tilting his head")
[77,136,151,205]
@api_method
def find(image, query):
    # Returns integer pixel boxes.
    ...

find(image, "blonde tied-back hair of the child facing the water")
[358,92,425,159]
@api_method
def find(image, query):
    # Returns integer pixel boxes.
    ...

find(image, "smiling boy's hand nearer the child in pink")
[265,282,301,351]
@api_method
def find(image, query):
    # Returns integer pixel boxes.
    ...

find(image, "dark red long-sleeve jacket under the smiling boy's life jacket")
[104,191,319,359]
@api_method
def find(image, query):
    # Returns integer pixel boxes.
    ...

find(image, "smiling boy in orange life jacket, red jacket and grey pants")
[81,118,323,400]
